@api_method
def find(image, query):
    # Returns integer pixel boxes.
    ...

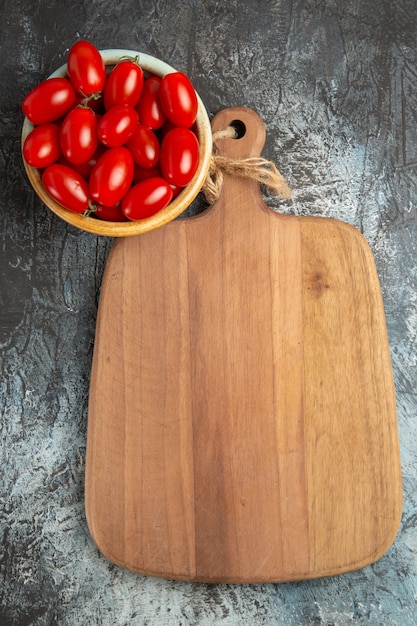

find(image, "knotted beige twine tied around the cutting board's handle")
[202,126,292,204]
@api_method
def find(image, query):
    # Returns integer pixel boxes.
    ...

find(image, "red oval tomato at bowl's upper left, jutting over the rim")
[22,78,76,125]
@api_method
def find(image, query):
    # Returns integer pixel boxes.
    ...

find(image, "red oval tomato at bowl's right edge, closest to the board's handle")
[160,128,200,187]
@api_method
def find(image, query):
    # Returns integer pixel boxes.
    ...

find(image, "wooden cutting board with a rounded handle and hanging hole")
[86,108,401,583]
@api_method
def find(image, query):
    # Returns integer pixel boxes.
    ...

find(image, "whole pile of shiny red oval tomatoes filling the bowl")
[22,40,200,221]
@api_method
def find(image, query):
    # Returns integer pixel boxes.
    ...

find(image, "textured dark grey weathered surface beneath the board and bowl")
[0,0,417,626]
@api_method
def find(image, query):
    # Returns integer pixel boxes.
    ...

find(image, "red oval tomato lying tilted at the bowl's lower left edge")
[42,163,88,213]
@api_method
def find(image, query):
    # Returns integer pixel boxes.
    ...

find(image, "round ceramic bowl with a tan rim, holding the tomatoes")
[22,49,212,237]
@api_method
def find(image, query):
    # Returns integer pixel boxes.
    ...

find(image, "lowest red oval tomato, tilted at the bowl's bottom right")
[122,178,172,220]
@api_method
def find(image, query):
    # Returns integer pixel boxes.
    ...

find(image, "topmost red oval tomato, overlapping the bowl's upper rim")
[67,40,106,96]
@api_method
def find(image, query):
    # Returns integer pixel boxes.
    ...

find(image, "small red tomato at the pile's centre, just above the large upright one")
[97,104,138,148]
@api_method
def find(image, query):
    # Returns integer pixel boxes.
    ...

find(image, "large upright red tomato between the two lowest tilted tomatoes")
[89,146,133,206]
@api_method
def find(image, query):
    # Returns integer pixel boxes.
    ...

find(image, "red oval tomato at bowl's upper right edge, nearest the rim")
[159,72,198,128]
